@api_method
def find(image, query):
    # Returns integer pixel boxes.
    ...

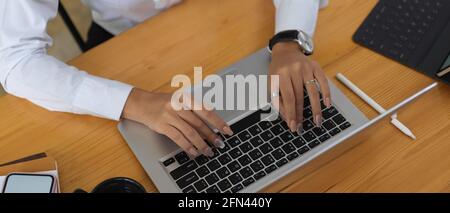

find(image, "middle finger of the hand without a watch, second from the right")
[178,110,225,148]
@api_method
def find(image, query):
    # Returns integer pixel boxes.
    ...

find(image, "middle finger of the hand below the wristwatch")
[292,70,304,134]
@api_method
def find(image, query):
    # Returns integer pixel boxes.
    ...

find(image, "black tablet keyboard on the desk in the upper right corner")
[354,0,449,64]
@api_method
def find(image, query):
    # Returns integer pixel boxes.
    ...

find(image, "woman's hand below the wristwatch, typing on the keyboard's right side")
[269,42,331,133]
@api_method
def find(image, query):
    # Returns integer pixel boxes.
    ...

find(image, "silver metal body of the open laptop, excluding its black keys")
[118,49,431,193]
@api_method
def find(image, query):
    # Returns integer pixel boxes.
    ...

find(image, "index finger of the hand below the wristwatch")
[280,76,297,132]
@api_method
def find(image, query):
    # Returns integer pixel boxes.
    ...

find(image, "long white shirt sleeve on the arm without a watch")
[0,0,132,120]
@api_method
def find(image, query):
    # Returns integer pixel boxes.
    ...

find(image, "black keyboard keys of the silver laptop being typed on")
[162,96,351,193]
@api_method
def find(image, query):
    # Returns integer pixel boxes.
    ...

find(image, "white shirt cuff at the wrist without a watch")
[73,75,133,121]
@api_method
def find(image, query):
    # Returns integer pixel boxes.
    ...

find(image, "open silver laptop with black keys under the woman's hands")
[118,49,431,193]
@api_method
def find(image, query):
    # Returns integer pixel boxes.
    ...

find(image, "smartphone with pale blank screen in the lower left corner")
[3,173,55,193]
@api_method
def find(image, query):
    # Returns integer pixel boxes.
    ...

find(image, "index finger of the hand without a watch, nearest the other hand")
[184,94,233,136]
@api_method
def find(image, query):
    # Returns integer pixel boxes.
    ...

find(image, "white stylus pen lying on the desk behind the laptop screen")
[336,73,416,140]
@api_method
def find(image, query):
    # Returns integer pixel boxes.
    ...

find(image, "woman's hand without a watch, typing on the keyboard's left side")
[122,89,233,157]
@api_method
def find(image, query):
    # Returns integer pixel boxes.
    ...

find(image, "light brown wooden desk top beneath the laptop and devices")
[0,0,450,192]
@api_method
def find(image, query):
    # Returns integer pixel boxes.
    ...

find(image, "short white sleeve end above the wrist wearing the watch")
[274,0,328,36]
